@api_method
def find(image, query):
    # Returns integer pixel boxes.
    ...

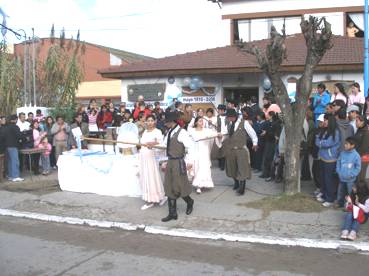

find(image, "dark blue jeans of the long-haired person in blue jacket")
[320,161,336,203]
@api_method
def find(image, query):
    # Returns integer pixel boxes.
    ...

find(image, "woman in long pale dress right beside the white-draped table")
[139,115,167,210]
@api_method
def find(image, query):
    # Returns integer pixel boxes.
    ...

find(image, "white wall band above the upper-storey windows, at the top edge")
[222,0,364,15]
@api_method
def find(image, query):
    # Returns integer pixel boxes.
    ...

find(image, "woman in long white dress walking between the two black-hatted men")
[188,117,217,194]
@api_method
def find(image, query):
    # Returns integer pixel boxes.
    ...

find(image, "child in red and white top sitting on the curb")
[341,184,369,241]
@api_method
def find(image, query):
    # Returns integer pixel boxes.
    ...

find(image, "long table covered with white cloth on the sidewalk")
[57,153,142,197]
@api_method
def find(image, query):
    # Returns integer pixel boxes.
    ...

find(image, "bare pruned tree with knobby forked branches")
[237,16,333,194]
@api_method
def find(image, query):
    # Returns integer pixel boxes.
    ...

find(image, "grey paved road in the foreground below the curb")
[0,217,369,276]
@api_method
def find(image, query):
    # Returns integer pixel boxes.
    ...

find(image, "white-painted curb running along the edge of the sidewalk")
[0,209,369,252]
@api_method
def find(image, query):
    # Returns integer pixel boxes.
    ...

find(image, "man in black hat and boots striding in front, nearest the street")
[161,111,194,222]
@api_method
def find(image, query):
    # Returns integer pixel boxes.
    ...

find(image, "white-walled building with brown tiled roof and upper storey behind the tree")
[100,0,364,107]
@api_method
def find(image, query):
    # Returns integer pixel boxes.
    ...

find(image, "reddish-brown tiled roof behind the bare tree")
[99,34,364,78]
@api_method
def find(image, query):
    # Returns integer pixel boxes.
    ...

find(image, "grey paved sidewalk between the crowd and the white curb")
[0,168,369,249]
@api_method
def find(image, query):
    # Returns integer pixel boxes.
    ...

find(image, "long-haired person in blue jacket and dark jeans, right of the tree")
[315,115,340,207]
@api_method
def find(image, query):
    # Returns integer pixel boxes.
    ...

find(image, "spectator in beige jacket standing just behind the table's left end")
[51,116,70,162]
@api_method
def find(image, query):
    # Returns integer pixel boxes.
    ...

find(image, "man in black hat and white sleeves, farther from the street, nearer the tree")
[223,109,258,195]
